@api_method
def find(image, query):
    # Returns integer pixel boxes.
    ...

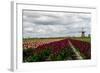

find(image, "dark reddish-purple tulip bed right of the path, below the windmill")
[69,39,91,58]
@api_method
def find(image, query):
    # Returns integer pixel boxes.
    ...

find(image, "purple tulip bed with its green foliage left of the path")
[23,39,76,62]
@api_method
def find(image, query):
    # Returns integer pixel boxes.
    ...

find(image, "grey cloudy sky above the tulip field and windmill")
[23,10,91,38]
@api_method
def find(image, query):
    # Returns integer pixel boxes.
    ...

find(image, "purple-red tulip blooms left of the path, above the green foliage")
[36,39,70,54]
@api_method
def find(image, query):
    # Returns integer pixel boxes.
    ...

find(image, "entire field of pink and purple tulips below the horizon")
[23,38,91,62]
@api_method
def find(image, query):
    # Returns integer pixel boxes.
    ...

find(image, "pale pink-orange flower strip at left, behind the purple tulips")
[23,38,64,49]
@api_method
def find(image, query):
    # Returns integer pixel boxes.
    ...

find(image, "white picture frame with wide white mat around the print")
[11,1,97,71]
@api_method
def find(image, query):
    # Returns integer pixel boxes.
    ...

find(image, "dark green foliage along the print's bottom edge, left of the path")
[23,48,75,62]
